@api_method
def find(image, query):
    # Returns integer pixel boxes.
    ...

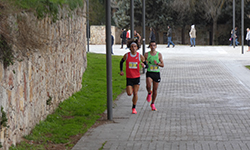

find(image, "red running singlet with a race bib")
[126,52,140,78]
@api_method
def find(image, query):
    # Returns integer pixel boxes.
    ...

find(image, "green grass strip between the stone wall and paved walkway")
[10,53,126,150]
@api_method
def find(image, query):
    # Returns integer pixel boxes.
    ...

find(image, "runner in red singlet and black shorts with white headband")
[120,39,147,114]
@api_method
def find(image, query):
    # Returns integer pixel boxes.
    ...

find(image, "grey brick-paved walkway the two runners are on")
[73,45,250,150]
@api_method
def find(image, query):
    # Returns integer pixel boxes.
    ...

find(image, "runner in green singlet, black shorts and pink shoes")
[144,41,164,111]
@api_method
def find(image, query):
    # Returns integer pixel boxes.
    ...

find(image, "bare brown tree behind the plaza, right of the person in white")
[199,0,226,45]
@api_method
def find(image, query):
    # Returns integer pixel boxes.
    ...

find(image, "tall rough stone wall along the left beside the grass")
[0,5,87,150]
